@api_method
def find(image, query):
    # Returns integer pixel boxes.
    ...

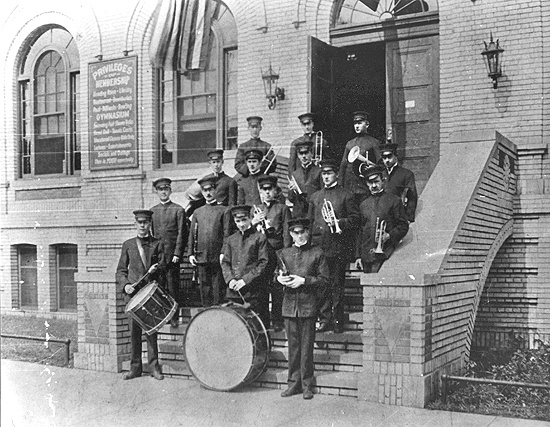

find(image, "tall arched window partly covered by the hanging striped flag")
[159,0,238,166]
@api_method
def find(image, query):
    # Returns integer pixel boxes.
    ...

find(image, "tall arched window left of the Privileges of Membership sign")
[18,27,80,178]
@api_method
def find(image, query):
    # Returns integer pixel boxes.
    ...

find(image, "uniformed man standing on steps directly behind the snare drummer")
[151,178,189,328]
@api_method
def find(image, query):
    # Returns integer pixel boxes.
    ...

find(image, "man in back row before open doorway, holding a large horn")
[338,111,380,206]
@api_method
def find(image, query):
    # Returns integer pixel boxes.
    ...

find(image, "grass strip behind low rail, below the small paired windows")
[1,315,78,366]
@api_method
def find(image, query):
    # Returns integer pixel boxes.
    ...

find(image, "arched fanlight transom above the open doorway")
[334,0,439,27]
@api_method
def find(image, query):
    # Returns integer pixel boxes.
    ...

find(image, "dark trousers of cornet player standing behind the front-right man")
[318,257,347,324]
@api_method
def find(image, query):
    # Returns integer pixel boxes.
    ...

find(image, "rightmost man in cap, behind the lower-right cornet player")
[380,144,418,222]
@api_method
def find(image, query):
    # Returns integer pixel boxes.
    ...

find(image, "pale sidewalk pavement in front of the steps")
[1,360,550,427]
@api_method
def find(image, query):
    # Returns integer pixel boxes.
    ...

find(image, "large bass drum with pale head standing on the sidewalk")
[184,303,270,391]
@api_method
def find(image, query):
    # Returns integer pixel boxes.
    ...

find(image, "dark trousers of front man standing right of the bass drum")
[285,317,315,391]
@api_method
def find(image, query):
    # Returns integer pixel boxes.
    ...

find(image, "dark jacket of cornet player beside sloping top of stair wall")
[359,191,409,262]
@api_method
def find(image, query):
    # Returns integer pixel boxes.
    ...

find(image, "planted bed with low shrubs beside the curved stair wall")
[428,339,550,421]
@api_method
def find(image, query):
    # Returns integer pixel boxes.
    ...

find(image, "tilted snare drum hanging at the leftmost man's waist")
[124,281,178,335]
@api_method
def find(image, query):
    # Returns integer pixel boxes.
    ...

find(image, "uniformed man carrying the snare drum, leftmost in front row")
[116,209,165,380]
